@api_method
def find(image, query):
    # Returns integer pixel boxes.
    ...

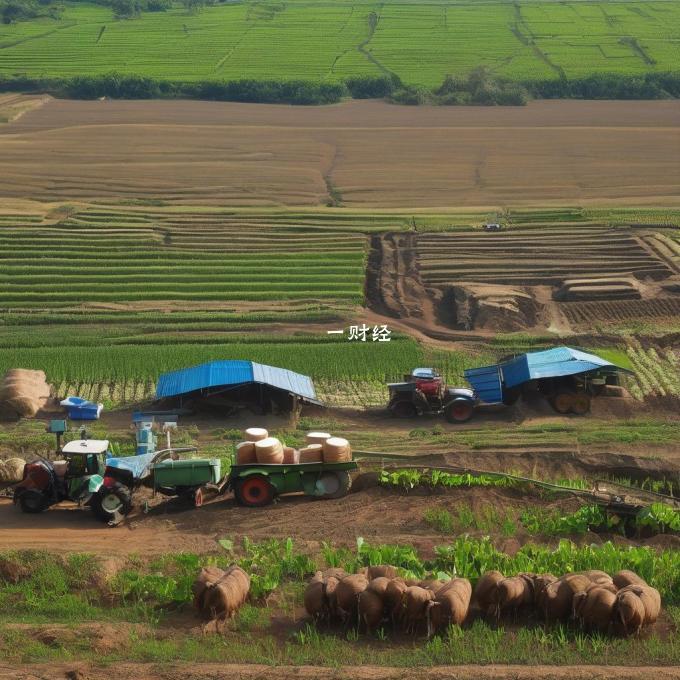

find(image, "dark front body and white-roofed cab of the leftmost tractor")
[14,439,110,513]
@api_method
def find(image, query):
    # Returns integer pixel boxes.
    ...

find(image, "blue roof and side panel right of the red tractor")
[465,347,627,403]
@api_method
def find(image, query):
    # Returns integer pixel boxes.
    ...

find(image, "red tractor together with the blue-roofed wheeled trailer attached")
[387,347,629,423]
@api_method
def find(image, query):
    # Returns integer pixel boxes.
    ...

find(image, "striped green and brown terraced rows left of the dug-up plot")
[0,211,366,308]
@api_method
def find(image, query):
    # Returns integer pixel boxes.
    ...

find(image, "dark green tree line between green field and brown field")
[0,68,680,106]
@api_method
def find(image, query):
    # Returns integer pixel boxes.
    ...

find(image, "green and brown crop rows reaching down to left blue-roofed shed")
[0,207,500,405]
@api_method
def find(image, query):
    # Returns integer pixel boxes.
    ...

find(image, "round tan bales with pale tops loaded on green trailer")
[236,427,352,465]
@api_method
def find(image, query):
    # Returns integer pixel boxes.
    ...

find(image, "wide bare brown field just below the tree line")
[0,100,680,207]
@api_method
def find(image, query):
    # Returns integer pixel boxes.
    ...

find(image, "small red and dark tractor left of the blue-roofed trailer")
[387,368,479,423]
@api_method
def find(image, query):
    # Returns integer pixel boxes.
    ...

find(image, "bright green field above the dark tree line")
[0,0,680,87]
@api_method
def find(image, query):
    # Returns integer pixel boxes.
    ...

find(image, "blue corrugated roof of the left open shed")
[156,360,321,404]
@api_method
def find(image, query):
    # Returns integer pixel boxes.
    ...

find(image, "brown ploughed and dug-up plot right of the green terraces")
[366,227,680,337]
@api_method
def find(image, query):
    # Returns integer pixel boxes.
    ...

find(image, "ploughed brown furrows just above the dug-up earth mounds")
[417,228,673,286]
